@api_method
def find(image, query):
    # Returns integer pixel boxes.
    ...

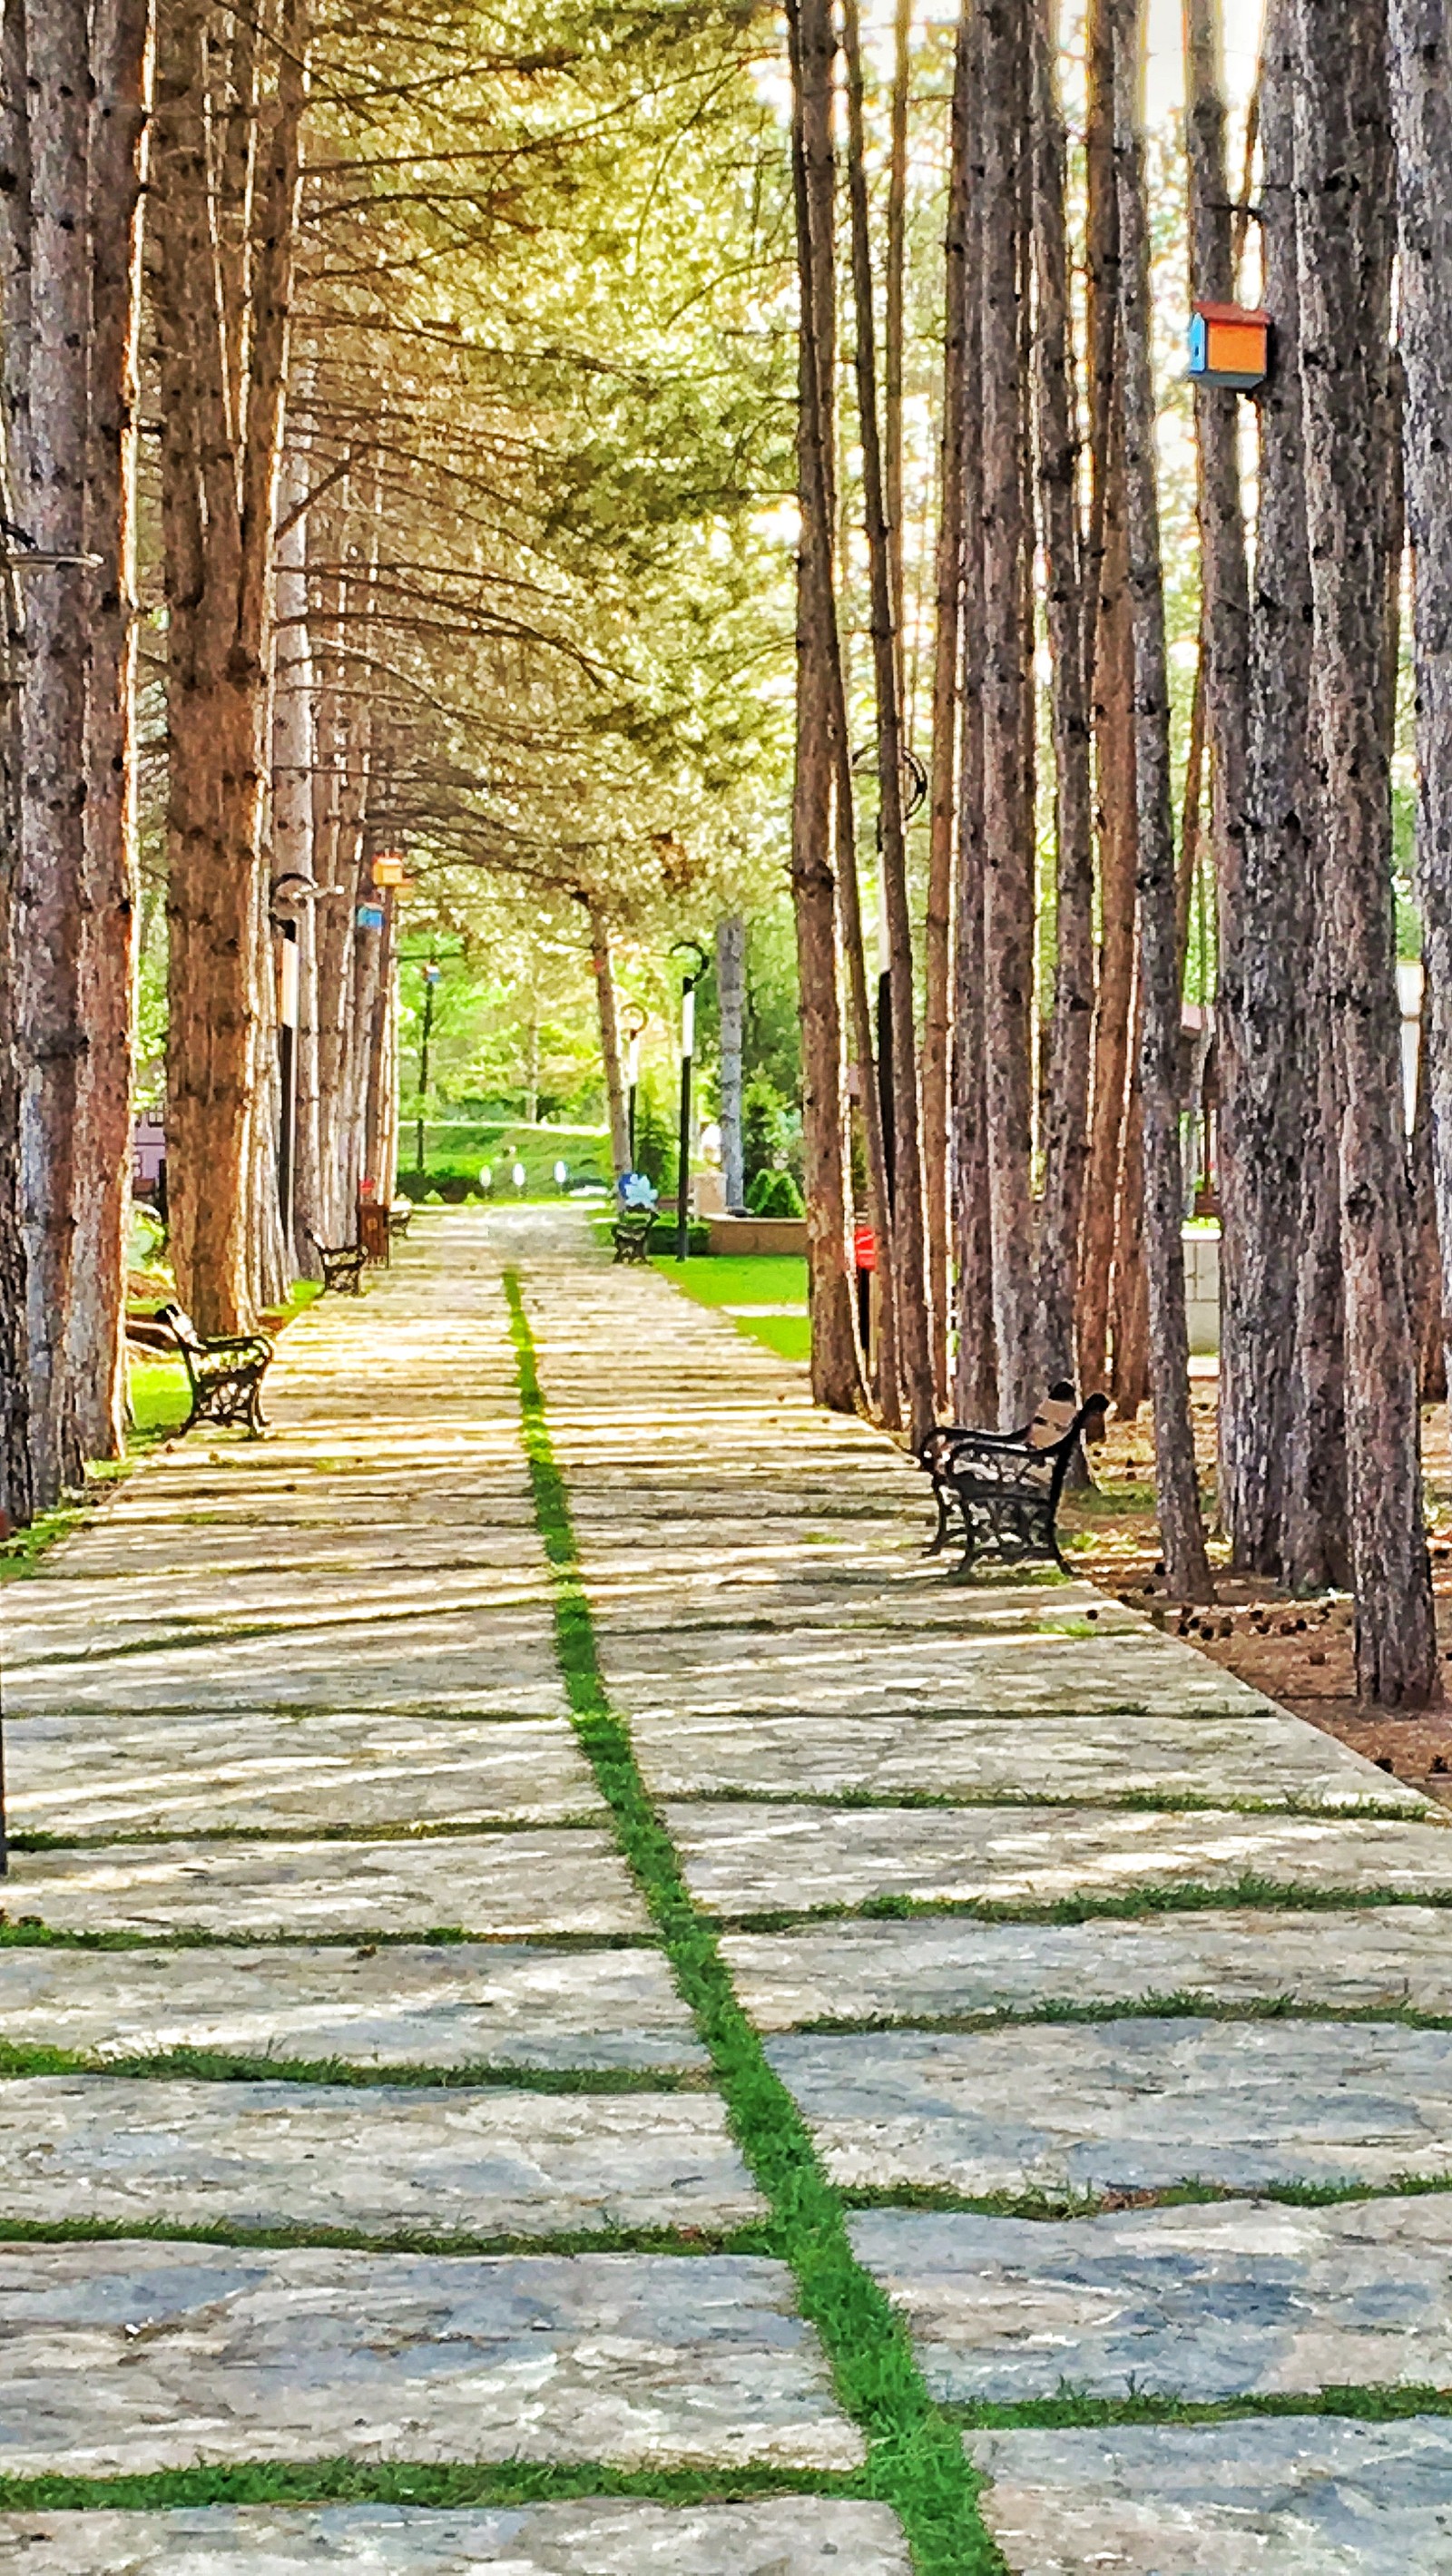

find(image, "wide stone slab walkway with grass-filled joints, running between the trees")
[0,1210,1452,2576]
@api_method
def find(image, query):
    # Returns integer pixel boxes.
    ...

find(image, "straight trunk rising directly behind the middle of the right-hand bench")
[978,0,1040,1425]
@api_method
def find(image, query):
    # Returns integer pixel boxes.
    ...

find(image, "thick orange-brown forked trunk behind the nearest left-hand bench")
[154,0,307,1332]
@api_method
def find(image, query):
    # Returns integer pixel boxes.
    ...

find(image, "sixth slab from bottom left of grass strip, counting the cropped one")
[5,1710,602,1837]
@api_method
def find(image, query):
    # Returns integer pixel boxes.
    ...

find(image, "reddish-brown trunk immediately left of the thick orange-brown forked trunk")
[67,0,152,1458]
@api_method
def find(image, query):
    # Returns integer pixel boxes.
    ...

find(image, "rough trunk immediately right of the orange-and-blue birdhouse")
[1218,0,1318,1579]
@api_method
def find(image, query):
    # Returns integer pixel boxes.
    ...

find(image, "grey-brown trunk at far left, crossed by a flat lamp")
[15,0,90,1510]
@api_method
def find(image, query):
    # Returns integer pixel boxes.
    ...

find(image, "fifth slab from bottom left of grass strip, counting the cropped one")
[5,1829,646,1940]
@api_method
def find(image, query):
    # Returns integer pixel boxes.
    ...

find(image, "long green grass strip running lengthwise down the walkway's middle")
[505,1270,1006,2576]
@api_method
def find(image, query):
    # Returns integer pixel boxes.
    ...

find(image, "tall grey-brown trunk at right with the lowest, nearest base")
[1295,0,1439,1708]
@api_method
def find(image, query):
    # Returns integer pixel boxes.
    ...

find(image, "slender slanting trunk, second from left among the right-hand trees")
[842,0,937,1443]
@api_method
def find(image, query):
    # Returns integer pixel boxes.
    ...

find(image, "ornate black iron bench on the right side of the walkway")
[917,1381,1110,1576]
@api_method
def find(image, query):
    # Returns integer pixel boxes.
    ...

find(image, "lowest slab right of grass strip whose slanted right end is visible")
[633,1705,1427,1814]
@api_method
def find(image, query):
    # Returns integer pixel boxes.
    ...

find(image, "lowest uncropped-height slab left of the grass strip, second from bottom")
[0,2244,862,2478]
